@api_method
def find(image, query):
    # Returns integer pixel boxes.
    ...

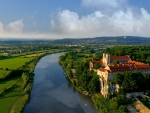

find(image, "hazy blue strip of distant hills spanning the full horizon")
[0,36,150,45]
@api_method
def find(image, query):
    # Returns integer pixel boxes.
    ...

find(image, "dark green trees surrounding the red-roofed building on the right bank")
[59,45,150,113]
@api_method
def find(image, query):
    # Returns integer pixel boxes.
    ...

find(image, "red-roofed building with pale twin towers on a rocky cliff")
[89,54,150,97]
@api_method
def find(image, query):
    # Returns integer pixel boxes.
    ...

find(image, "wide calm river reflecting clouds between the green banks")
[23,53,97,113]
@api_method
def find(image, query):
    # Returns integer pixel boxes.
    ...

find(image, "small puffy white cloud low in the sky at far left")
[5,20,24,34]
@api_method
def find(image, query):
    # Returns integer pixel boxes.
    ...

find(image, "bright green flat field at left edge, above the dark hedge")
[0,57,34,69]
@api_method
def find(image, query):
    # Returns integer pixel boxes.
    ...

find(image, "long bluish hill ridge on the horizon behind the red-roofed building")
[52,36,150,44]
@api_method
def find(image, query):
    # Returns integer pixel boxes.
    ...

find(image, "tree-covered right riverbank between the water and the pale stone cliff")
[59,52,128,113]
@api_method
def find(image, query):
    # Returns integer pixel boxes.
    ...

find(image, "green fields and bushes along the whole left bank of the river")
[0,40,68,113]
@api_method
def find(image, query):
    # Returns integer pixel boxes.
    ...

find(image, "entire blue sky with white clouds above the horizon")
[0,0,150,39]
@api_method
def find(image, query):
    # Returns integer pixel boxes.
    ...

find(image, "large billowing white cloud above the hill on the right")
[51,7,150,37]
